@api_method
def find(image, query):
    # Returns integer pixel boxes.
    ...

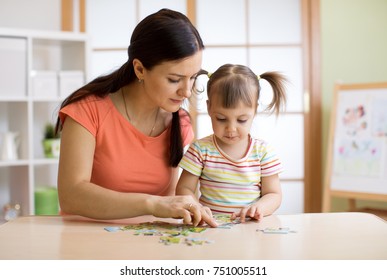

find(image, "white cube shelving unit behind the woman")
[0,28,90,216]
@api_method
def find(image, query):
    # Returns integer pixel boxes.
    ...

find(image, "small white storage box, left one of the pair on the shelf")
[31,71,58,99]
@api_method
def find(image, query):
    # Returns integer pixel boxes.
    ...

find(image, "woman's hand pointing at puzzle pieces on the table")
[148,195,217,227]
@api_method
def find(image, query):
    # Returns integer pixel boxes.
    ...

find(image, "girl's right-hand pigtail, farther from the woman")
[258,72,288,115]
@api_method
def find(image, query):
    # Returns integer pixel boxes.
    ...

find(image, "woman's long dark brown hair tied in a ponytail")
[56,9,204,167]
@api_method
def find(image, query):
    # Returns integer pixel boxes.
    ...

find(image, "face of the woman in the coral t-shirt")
[143,51,202,112]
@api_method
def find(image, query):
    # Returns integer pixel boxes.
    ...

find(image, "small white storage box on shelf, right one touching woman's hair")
[59,71,85,98]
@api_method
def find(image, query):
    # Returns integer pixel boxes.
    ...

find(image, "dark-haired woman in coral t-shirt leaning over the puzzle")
[57,9,216,226]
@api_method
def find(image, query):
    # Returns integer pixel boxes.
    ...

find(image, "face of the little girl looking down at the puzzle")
[207,89,256,149]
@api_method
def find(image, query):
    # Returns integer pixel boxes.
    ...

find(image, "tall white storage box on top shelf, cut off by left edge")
[0,37,27,98]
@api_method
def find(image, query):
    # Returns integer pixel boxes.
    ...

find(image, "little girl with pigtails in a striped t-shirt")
[176,64,286,222]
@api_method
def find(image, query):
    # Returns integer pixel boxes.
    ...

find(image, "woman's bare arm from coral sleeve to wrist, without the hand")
[58,117,150,219]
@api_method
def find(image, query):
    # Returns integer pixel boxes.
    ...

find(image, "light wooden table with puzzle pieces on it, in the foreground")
[0,213,387,260]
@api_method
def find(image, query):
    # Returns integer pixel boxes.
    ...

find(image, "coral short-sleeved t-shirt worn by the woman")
[59,96,193,195]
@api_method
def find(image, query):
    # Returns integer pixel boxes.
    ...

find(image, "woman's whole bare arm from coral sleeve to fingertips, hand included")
[58,117,216,225]
